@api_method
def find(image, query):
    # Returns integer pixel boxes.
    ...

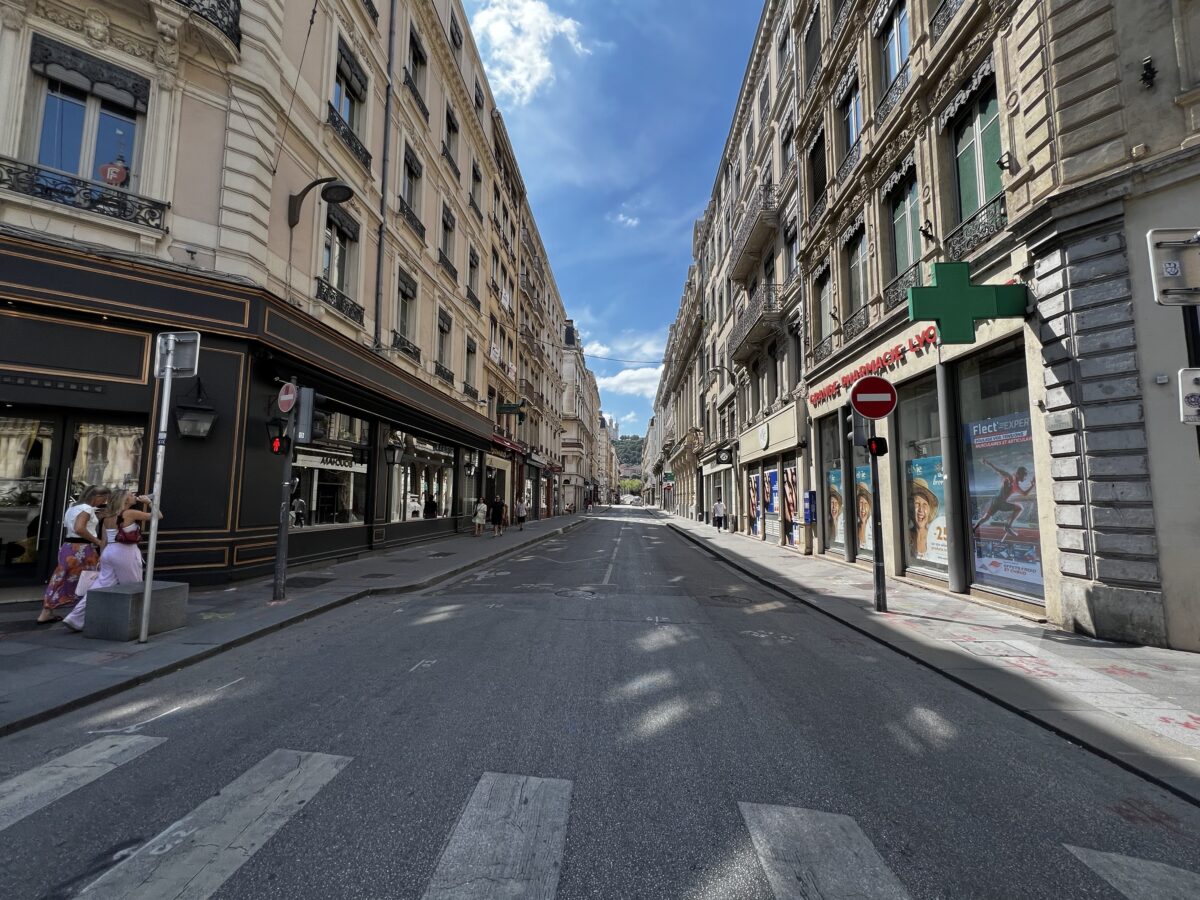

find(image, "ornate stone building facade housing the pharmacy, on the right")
[656,0,1200,650]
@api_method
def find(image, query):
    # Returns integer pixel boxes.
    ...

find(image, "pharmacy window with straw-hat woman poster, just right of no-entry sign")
[898,374,949,576]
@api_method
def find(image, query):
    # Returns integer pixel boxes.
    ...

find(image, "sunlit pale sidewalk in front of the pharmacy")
[653,509,1200,804]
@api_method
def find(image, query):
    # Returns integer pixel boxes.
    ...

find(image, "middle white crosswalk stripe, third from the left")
[422,772,571,900]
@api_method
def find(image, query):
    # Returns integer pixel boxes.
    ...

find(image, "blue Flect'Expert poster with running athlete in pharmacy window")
[962,413,1042,596]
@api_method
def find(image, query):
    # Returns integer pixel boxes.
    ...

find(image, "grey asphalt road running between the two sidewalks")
[0,510,1200,900]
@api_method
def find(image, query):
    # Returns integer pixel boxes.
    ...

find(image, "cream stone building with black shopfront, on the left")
[0,0,580,592]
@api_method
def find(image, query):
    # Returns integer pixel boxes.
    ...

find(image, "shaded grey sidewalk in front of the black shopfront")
[0,515,587,734]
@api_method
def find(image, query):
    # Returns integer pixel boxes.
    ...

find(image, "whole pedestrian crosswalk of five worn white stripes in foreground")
[0,734,1200,900]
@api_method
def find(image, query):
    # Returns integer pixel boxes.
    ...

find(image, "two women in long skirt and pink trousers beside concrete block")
[37,485,162,631]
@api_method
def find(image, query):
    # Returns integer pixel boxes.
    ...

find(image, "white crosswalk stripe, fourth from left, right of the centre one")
[738,803,908,900]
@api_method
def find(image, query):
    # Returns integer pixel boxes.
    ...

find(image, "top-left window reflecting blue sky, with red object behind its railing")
[26,35,150,190]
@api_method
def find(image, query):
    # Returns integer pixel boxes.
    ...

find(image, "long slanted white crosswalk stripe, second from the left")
[80,750,350,900]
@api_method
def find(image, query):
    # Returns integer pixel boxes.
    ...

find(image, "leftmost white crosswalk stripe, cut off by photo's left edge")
[0,734,167,832]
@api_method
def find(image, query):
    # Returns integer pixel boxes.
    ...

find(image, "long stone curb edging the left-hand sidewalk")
[0,518,590,737]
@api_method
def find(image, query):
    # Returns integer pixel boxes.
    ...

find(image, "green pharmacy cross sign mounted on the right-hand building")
[908,263,1028,343]
